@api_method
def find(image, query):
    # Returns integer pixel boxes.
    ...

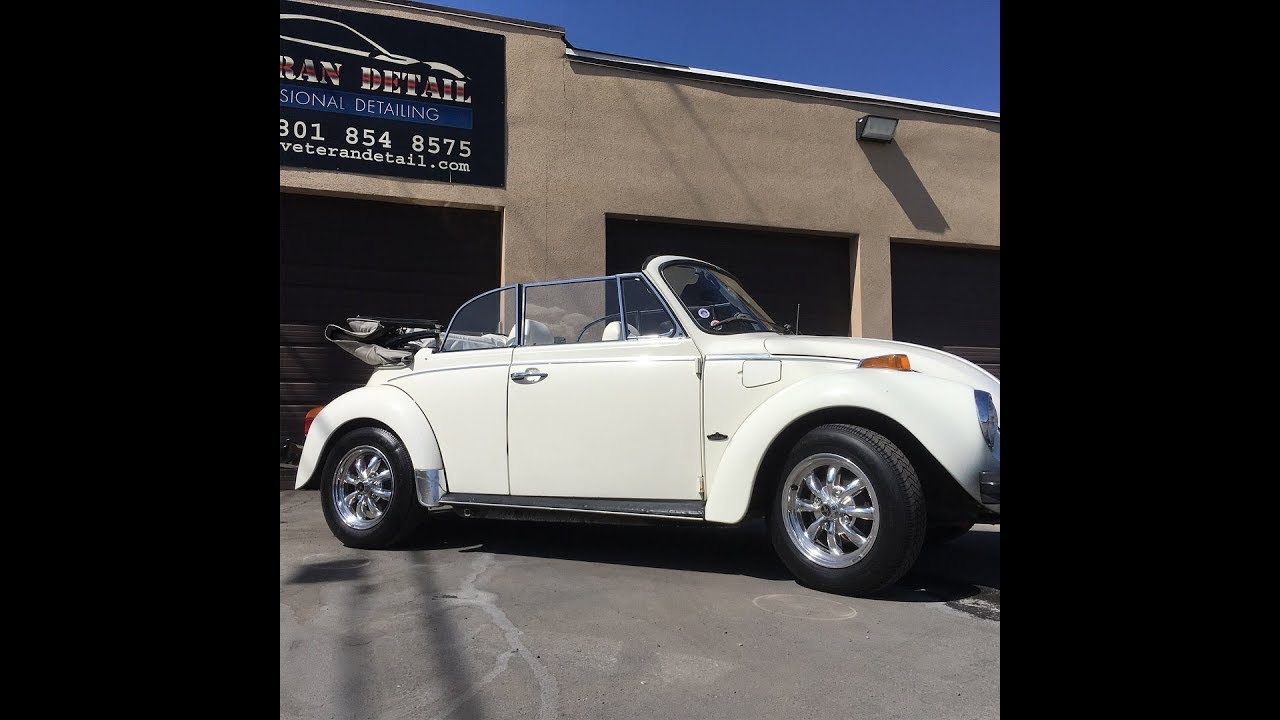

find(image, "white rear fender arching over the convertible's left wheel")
[293,384,444,491]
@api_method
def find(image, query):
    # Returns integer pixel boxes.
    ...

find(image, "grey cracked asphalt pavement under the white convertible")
[280,491,1000,720]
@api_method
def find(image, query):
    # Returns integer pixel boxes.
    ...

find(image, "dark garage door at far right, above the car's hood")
[890,242,1000,378]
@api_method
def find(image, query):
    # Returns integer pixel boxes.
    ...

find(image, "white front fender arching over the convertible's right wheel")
[705,369,1000,523]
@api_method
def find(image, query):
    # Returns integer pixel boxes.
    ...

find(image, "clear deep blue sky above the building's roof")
[433,0,1000,113]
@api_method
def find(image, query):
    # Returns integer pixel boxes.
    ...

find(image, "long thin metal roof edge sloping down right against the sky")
[564,46,1000,123]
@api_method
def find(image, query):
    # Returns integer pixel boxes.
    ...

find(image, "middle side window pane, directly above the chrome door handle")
[525,278,622,345]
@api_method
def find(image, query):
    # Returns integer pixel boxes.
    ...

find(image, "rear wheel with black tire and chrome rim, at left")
[320,428,426,550]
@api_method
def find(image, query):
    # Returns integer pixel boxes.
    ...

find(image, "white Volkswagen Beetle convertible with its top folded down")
[297,255,1000,594]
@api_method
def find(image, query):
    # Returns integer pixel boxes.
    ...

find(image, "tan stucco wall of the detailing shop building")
[280,1,1000,337]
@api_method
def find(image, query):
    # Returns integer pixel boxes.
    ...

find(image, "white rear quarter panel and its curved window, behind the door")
[388,286,517,495]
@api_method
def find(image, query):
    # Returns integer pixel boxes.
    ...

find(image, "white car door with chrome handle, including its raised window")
[507,275,701,500]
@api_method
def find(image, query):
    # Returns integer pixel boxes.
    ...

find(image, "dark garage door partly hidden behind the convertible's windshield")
[604,218,852,336]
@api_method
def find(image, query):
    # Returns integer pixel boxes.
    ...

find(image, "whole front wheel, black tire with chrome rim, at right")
[768,424,927,594]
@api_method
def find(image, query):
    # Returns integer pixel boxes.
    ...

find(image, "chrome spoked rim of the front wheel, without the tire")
[781,452,879,568]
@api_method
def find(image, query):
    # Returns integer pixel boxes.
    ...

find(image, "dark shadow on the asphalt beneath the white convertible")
[402,511,1000,602]
